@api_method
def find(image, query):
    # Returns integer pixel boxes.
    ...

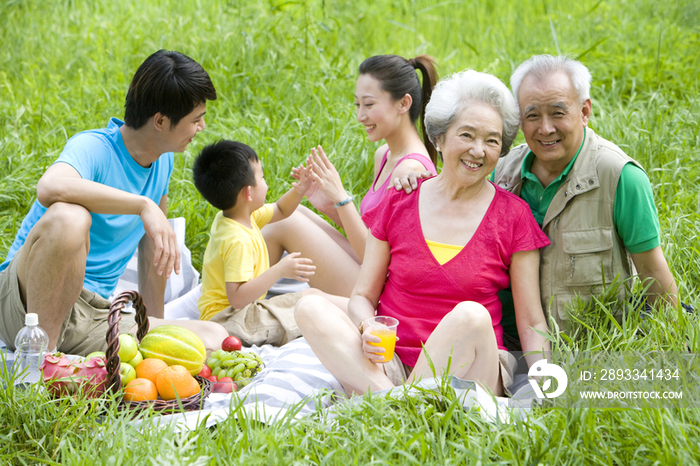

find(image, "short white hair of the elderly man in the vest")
[510,54,591,104]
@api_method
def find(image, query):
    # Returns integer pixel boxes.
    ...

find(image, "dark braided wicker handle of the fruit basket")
[105,291,148,394]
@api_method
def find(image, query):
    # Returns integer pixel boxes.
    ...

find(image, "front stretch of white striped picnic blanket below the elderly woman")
[130,338,532,429]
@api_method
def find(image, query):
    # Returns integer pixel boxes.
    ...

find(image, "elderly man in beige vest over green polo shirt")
[493,55,677,329]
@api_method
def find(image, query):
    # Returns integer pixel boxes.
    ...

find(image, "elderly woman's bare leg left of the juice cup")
[295,296,394,395]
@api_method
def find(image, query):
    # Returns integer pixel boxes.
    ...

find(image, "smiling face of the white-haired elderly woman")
[437,102,503,185]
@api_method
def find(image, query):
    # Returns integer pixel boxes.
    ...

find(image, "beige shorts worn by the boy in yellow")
[210,291,302,346]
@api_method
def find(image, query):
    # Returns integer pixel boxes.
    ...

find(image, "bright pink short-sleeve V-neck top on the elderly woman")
[362,180,549,366]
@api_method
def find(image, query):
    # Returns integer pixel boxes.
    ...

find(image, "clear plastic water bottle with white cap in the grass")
[14,313,49,384]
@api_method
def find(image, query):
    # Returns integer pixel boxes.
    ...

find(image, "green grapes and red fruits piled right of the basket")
[199,336,263,393]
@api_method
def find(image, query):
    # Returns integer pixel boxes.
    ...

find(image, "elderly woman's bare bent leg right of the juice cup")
[410,301,503,395]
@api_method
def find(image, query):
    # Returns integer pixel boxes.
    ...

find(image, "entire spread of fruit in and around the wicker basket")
[41,325,263,401]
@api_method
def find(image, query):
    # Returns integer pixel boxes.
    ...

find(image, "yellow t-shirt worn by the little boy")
[197,204,274,320]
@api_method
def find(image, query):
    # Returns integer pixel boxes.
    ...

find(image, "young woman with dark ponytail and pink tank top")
[262,55,437,296]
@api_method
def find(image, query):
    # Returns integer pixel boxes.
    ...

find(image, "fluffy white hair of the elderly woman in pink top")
[425,70,520,157]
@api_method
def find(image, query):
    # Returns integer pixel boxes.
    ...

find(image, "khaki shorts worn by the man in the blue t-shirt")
[0,248,136,355]
